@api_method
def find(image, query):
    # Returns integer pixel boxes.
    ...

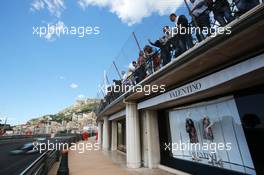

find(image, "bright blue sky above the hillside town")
[0,0,187,124]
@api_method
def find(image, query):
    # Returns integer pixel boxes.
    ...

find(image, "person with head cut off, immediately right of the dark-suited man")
[190,0,211,42]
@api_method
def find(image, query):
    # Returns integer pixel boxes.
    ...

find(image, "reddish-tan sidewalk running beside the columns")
[49,138,178,175]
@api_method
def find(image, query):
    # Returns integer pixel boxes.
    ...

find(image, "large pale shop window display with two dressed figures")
[167,98,256,174]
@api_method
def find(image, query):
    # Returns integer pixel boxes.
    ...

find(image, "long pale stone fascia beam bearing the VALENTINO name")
[138,56,264,109]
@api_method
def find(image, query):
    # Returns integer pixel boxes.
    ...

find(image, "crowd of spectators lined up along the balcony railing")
[100,0,259,112]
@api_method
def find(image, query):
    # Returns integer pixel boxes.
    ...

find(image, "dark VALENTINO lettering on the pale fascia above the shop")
[169,82,202,98]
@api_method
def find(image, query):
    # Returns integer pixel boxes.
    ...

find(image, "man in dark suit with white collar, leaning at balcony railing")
[170,13,193,51]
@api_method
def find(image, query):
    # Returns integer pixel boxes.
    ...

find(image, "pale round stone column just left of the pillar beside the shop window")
[126,103,141,168]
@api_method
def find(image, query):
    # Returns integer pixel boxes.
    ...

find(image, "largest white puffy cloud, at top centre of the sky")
[78,0,183,25]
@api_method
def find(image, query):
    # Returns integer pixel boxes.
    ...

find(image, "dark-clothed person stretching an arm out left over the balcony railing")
[148,26,171,66]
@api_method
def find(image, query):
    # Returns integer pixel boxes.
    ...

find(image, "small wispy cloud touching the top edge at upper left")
[30,0,66,18]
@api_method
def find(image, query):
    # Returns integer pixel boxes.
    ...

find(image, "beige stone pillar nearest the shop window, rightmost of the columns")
[145,110,160,168]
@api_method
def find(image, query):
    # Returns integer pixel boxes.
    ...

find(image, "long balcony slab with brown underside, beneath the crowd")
[98,3,264,116]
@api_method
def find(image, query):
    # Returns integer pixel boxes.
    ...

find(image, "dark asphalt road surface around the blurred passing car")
[0,139,40,175]
